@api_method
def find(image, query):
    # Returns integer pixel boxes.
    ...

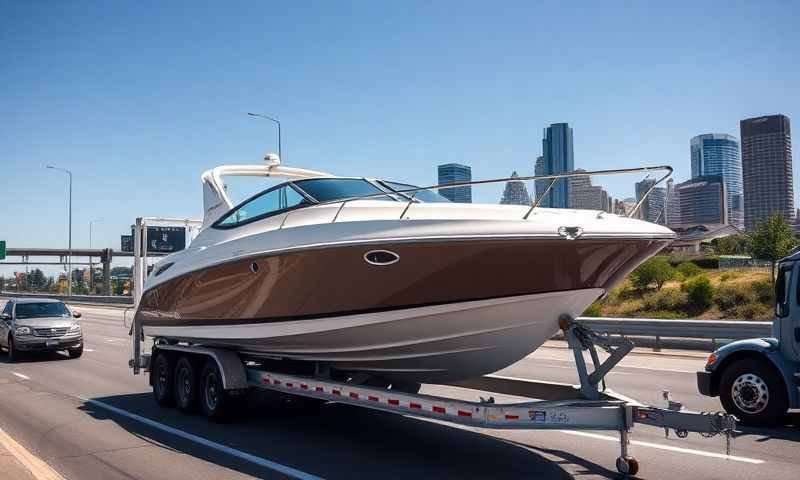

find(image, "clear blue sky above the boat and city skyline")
[0,0,800,270]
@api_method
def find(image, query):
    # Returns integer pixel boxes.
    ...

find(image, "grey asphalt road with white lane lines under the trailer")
[0,301,800,480]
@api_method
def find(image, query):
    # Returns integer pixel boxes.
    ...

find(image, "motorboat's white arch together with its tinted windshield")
[202,154,449,229]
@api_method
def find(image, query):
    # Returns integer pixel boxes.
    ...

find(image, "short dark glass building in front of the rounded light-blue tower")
[675,175,730,227]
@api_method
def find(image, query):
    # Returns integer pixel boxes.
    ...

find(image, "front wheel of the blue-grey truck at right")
[719,358,789,426]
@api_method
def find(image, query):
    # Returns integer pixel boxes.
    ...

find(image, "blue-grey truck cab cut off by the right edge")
[697,251,800,425]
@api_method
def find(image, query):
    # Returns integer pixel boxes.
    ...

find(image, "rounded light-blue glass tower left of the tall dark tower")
[689,133,744,230]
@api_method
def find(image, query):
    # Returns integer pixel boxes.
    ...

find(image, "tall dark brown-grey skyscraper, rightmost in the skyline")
[739,115,794,230]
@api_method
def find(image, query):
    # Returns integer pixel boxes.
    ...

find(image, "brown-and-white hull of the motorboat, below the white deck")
[136,238,668,382]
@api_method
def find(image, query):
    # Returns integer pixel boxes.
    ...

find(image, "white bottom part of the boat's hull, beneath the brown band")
[144,289,602,383]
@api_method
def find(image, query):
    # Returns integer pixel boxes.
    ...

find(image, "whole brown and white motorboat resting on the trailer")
[136,155,675,384]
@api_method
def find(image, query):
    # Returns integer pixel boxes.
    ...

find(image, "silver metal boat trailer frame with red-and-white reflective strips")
[130,316,736,475]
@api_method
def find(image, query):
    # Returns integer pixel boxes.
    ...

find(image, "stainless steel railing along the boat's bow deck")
[279,165,673,228]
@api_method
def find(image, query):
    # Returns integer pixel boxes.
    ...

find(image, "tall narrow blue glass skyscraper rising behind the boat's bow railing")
[536,123,575,208]
